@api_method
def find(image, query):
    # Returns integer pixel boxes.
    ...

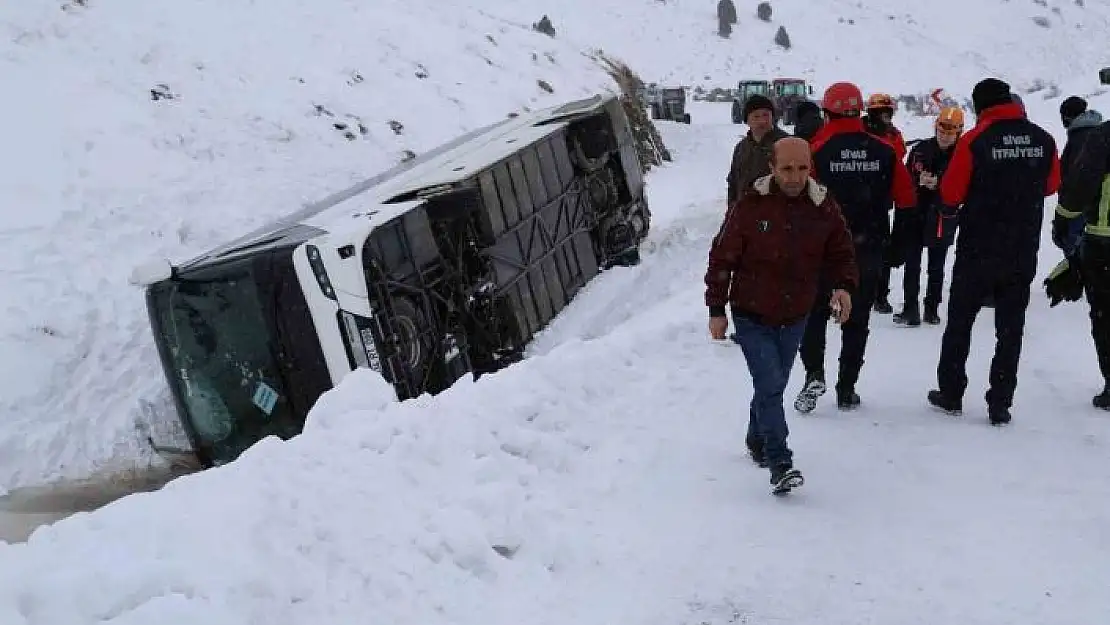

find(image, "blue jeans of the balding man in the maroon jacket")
[733,315,806,467]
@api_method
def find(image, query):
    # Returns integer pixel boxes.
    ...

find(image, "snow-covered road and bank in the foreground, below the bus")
[0,102,1110,625]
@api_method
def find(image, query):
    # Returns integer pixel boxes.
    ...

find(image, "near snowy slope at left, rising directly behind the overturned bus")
[0,0,626,492]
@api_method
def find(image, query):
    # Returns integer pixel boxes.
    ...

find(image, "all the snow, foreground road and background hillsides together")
[0,0,1110,625]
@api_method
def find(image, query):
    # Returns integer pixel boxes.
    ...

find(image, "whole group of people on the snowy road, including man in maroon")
[705,78,1110,494]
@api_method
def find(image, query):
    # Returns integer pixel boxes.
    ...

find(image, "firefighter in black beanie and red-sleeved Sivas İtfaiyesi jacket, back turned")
[928,78,1060,425]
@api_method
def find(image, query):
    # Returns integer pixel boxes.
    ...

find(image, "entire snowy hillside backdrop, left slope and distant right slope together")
[0,0,1110,493]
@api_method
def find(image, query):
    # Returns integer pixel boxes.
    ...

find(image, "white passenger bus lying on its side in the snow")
[132,94,650,466]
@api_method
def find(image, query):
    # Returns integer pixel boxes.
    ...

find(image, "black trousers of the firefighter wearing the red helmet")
[798,246,885,391]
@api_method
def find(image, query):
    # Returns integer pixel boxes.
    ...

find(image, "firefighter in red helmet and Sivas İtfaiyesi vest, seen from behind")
[794,82,917,413]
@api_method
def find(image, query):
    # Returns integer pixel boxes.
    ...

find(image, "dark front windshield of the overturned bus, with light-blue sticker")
[150,261,304,458]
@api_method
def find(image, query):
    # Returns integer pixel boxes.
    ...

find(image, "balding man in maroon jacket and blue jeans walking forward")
[705,138,859,494]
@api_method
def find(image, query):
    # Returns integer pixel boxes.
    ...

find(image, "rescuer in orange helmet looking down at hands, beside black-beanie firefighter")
[891,107,963,327]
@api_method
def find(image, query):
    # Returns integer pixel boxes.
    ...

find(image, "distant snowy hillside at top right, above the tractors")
[486,0,1110,93]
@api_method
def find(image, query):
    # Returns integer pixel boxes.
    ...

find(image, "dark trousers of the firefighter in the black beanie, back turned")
[937,251,1036,409]
